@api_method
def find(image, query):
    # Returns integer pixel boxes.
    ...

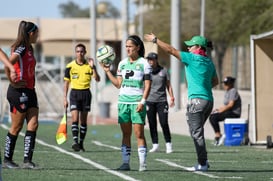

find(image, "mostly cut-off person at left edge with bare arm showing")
[0,48,17,178]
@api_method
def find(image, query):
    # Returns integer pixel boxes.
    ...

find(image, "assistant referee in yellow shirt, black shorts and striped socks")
[64,44,100,152]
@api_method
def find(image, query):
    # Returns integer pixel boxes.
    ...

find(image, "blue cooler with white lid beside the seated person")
[224,118,248,146]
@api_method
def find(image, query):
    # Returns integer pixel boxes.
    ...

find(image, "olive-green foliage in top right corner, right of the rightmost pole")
[206,0,273,45]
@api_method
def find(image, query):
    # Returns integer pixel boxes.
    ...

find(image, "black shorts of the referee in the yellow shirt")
[70,89,92,112]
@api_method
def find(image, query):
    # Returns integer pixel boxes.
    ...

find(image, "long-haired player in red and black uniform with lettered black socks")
[3,21,39,169]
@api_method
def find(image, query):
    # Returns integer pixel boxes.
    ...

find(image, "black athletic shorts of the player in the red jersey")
[7,85,39,113]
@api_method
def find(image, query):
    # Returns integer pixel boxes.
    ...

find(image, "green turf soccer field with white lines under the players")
[0,123,273,181]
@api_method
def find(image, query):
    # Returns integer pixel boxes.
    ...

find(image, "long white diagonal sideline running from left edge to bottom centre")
[1,124,139,181]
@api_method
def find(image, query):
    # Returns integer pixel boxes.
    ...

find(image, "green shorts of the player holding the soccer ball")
[118,104,146,124]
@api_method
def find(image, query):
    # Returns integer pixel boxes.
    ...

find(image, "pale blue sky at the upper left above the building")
[0,0,132,18]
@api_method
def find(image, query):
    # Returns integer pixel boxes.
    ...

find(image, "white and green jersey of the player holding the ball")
[117,57,152,104]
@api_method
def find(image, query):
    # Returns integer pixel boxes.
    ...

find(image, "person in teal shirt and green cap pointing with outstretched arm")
[145,33,218,171]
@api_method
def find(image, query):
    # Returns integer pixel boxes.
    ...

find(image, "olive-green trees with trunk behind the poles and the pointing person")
[140,0,273,85]
